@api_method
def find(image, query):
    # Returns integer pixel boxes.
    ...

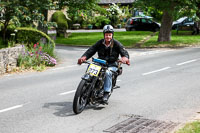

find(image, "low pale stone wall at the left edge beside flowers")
[0,45,25,75]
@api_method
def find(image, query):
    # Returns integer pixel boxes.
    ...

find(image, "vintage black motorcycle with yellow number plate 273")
[73,58,122,114]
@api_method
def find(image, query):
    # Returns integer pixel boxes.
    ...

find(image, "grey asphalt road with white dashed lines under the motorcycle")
[0,46,200,133]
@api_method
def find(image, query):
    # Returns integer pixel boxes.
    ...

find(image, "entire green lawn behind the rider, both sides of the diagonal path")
[56,30,200,48]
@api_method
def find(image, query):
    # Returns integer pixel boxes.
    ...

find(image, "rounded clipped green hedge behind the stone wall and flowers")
[16,27,55,48]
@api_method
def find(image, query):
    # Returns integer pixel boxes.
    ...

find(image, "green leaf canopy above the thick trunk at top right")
[134,0,200,21]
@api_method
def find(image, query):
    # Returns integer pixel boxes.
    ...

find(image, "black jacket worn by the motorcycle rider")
[82,39,129,66]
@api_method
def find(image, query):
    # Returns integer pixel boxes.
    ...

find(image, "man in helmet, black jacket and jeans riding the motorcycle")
[77,25,130,103]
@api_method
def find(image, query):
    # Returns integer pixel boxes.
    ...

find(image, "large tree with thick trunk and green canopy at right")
[135,0,199,42]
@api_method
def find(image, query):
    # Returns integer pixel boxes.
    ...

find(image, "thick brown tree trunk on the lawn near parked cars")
[158,10,173,42]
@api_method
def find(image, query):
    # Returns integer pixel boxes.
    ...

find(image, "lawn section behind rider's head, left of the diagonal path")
[56,31,152,47]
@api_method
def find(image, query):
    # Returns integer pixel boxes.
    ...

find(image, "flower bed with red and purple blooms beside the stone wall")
[17,43,56,70]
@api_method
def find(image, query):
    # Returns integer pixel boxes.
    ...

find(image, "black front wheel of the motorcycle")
[73,80,88,114]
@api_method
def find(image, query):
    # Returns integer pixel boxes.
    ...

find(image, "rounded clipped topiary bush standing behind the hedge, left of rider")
[52,11,68,29]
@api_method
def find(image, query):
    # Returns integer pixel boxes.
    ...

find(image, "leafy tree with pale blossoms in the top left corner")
[0,0,55,41]
